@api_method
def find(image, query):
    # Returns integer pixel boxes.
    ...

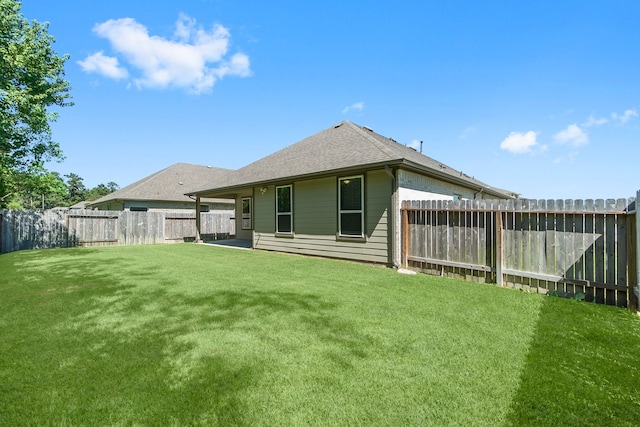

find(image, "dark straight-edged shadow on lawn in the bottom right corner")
[507,297,640,426]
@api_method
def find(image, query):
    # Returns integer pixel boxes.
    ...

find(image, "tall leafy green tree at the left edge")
[0,0,73,207]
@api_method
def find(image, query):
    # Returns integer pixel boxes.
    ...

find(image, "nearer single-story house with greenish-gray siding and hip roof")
[190,121,516,265]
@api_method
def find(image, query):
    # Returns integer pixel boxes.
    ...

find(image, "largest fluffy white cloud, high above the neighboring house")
[78,14,251,93]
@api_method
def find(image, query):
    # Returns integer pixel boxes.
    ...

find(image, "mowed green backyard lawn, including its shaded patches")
[0,244,640,426]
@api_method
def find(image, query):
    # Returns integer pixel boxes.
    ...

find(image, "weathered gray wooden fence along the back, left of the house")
[0,210,235,252]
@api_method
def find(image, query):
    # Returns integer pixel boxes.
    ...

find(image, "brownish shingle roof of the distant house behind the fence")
[89,163,232,206]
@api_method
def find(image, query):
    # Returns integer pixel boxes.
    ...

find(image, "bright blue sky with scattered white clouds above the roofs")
[22,0,640,199]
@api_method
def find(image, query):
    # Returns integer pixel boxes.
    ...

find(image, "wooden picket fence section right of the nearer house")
[402,198,637,311]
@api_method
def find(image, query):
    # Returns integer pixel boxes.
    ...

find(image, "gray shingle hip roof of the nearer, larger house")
[189,120,515,198]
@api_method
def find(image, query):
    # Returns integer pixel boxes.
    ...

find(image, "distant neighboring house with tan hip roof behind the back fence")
[87,163,234,212]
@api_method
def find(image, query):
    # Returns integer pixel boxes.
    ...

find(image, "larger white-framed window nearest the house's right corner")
[338,176,364,237]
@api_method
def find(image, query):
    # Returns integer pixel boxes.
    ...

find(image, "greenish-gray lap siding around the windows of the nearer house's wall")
[253,171,392,264]
